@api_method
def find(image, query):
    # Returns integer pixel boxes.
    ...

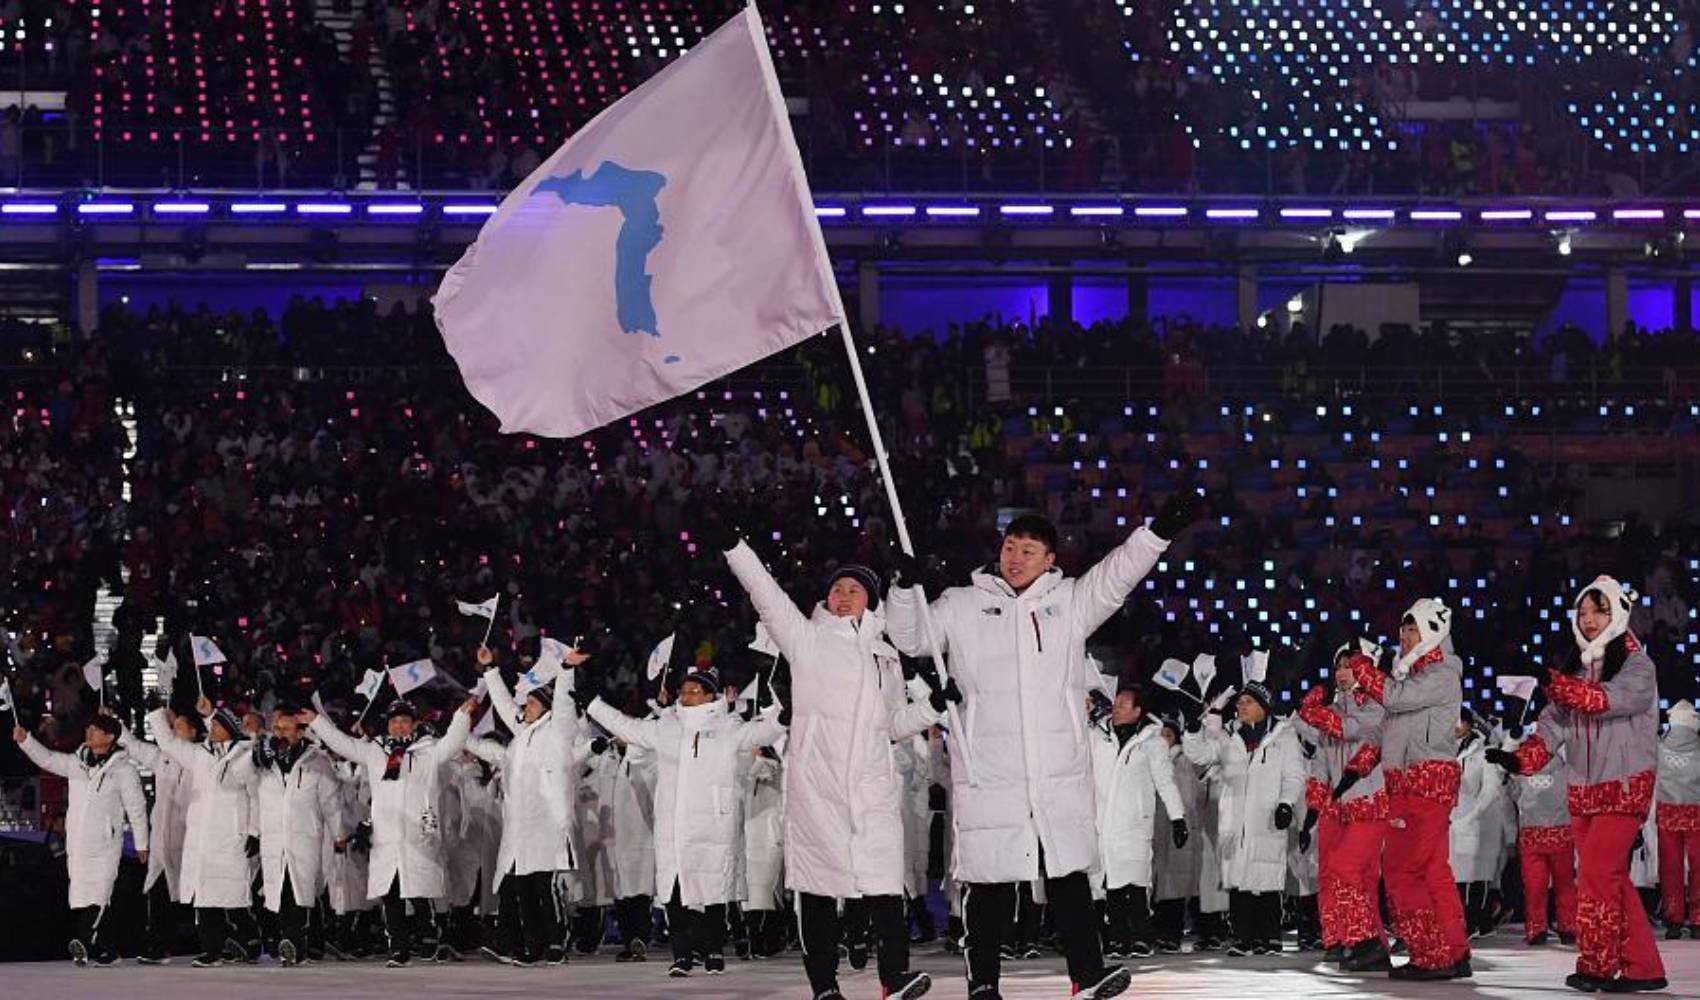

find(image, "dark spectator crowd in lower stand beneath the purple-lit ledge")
[0,301,1700,755]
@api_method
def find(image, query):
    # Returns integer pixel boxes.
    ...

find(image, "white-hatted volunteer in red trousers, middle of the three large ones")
[1352,599,1472,980]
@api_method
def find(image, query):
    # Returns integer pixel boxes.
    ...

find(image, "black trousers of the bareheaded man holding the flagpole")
[962,871,1105,990]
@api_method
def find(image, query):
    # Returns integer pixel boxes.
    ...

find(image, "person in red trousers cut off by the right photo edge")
[1654,701,1700,940]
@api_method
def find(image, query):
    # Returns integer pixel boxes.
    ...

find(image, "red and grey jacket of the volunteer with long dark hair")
[1516,634,1659,816]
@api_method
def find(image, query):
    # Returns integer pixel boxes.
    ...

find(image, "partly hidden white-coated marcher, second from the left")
[117,714,195,966]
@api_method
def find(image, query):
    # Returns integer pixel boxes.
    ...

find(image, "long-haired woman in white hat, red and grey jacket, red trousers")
[1493,577,1668,993]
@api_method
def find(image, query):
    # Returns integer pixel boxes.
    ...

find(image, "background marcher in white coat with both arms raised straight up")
[478,650,588,966]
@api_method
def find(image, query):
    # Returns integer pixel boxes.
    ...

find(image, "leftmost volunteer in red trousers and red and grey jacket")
[1299,643,1392,973]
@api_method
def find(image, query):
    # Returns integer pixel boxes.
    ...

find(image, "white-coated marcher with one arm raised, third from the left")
[148,697,260,968]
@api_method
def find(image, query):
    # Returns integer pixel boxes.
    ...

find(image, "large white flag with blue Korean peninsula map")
[432,3,843,437]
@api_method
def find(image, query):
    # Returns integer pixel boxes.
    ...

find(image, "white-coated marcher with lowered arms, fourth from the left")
[223,709,352,966]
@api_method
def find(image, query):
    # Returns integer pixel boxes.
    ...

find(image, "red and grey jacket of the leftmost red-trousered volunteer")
[1299,687,1387,823]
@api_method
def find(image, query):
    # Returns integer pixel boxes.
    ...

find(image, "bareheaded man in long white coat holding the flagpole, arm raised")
[887,491,1202,1000]
